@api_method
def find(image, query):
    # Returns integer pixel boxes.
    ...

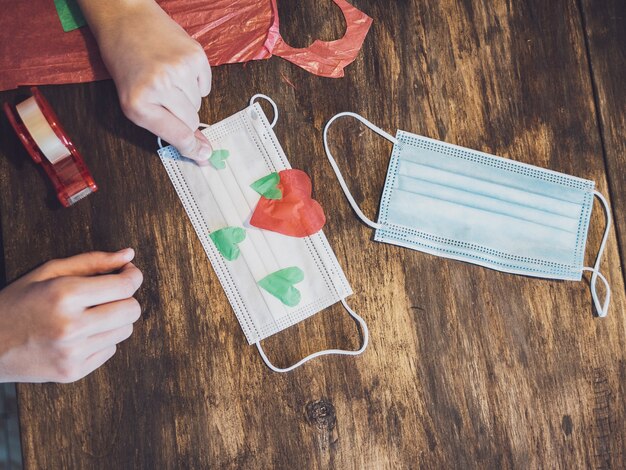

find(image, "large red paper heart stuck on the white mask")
[250,169,326,237]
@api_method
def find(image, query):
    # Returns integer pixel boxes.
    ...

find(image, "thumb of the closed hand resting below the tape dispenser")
[31,248,135,281]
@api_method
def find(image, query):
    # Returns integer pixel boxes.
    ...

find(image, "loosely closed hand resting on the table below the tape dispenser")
[0,249,143,383]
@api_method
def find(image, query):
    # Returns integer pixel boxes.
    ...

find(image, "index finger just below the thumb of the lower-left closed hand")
[65,263,143,307]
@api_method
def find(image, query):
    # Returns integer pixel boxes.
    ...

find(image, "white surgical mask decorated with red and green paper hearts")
[158,95,368,372]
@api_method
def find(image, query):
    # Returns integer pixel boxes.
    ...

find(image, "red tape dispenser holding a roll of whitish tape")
[4,87,98,207]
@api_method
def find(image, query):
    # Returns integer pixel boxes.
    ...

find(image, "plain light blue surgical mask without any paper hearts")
[324,113,611,317]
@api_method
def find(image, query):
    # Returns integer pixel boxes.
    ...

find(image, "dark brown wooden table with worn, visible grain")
[0,0,626,469]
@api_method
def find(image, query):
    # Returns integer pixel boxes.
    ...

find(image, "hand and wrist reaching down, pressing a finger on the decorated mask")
[80,0,212,163]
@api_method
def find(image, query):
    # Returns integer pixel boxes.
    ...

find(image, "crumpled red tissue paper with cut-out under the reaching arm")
[0,0,372,90]
